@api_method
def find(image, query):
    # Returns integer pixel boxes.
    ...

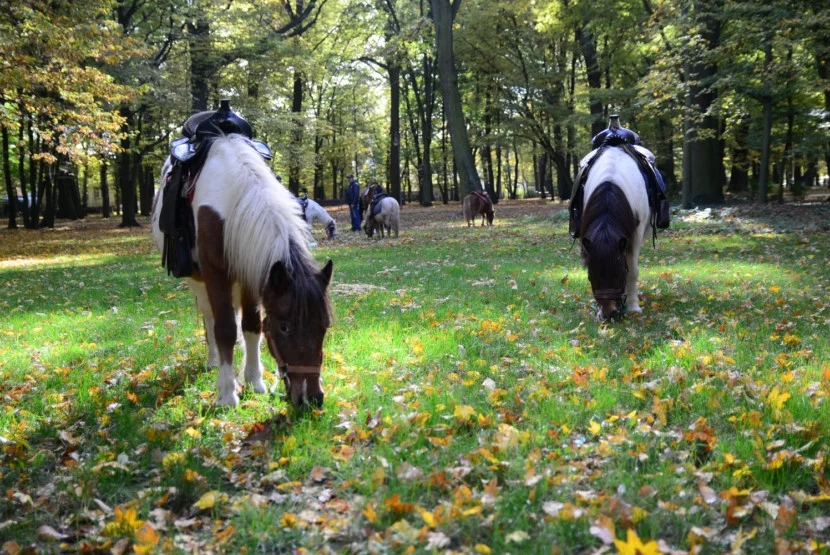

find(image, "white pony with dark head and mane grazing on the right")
[580,147,651,320]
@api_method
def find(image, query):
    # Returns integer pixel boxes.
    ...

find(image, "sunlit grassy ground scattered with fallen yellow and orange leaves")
[0,197,830,554]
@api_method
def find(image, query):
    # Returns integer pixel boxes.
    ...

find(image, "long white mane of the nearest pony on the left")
[209,134,317,293]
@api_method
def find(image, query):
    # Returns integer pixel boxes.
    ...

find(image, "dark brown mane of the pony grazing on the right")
[580,181,638,271]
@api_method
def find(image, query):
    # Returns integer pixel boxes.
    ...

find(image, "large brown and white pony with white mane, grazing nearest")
[152,134,332,406]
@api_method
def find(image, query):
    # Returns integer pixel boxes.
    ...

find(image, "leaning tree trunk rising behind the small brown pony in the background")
[431,0,481,198]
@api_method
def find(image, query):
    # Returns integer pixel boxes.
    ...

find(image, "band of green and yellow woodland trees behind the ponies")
[0,0,830,227]
